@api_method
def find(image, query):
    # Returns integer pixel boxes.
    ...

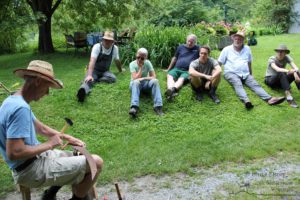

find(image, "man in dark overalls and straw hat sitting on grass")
[77,31,124,102]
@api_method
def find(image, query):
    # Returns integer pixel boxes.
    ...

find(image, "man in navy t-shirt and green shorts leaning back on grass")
[165,34,199,100]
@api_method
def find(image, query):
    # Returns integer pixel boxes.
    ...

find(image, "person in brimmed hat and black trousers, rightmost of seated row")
[265,44,300,108]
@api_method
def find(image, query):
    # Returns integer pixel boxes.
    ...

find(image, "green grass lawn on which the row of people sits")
[0,34,300,195]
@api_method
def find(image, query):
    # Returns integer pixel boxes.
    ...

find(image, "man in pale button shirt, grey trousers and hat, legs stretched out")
[218,31,285,110]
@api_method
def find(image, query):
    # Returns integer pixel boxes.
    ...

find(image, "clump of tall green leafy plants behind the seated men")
[120,25,213,68]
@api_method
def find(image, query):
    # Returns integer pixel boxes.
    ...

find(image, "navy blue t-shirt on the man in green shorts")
[175,44,199,71]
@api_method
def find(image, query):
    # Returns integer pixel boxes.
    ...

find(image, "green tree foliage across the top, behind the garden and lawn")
[0,0,295,54]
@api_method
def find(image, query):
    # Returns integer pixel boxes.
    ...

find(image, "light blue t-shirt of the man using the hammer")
[0,96,39,169]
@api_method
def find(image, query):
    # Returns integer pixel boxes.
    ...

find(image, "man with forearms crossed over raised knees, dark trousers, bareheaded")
[189,45,222,104]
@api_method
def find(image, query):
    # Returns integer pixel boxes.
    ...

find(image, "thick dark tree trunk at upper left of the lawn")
[38,18,54,53]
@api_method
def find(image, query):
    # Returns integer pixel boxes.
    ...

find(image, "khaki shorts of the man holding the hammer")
[13,150,87,188]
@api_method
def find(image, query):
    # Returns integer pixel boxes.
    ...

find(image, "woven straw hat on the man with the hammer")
[14,60,63,89]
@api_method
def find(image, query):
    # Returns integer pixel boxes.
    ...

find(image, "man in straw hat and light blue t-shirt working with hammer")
[0,60,103,200]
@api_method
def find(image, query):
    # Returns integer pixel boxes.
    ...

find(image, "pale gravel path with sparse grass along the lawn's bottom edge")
[6,154,300,200]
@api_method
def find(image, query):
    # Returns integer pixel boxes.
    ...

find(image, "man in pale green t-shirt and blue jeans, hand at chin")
[129,48,163,118]
